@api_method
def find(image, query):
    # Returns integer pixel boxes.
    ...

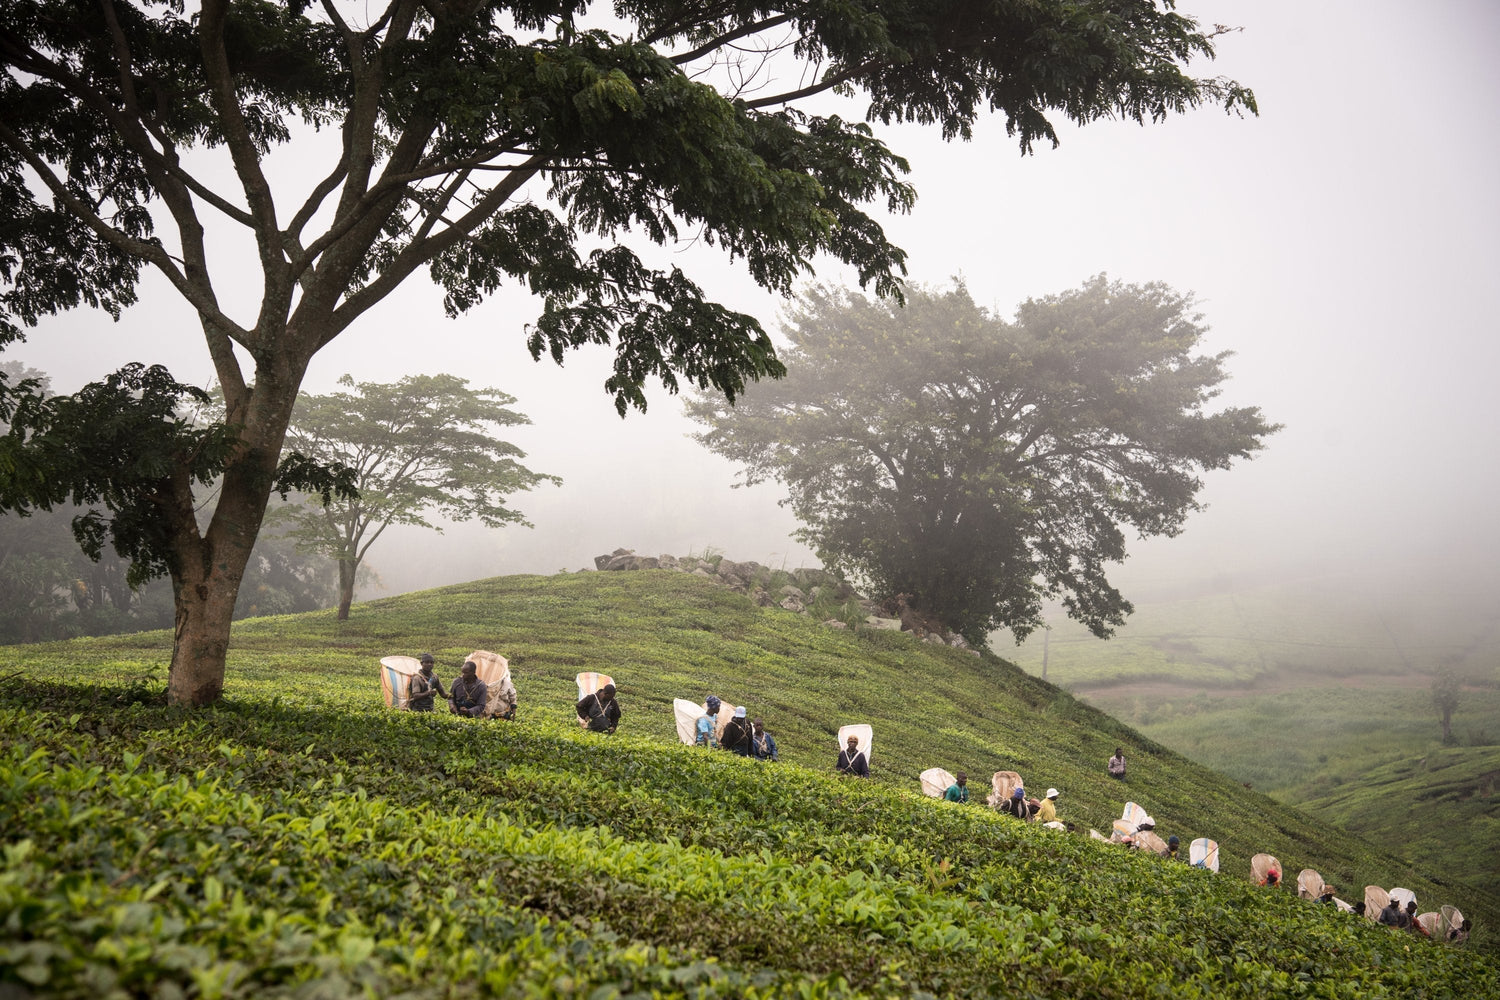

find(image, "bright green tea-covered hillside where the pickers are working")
[0,573,1500,999]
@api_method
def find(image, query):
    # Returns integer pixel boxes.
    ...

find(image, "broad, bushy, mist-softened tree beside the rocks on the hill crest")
[689,276,1277,645]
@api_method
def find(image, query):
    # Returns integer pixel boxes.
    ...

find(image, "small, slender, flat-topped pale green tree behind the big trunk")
[275,375,561,621]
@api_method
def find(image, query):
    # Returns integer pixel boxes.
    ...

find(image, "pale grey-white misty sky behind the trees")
[6,0,1500,632]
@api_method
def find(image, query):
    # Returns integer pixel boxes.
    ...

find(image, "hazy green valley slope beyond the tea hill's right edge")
[1013,577,1500,894]
